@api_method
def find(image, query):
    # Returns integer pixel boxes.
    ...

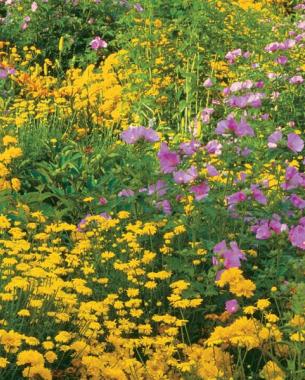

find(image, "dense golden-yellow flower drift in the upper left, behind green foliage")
[0,20,182,134]
